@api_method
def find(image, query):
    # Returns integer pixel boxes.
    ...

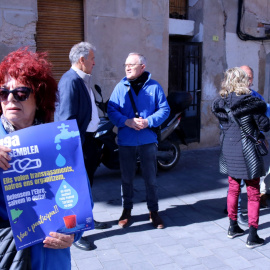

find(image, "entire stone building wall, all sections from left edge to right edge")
[0,0,270,148]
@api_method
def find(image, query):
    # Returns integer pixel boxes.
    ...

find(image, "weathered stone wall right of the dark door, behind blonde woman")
[189,0,270,148]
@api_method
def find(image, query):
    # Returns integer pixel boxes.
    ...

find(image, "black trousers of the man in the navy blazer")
[82,132,99,187]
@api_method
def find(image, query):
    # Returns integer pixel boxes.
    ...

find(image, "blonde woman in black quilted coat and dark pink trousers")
[212,67,270,248]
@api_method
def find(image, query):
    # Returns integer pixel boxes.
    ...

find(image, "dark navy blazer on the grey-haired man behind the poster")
[54,68,92,144]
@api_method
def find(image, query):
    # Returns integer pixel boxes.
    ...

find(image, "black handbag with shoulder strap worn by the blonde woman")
[225,108,268,156]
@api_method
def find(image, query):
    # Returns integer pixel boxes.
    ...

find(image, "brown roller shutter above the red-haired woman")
[36,0,84,81]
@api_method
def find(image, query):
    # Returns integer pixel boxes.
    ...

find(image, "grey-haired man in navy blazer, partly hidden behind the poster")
[54,42,107,250]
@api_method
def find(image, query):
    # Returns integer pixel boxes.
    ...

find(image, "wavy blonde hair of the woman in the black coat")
[219,67,251,97]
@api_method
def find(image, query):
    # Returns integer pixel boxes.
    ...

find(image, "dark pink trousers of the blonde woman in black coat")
[227,176,260,229]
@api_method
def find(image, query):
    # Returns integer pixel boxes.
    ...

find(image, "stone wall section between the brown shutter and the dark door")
[85,0,169,100]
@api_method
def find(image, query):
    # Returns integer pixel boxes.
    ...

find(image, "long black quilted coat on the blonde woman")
[212,93,270,180]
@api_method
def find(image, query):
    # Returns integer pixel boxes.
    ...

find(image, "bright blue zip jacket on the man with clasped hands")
[108,72,170,146]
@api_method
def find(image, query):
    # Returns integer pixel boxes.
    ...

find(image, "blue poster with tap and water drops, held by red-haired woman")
[0,120,94,250]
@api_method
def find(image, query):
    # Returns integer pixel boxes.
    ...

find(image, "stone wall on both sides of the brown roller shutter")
[0,0,169,103]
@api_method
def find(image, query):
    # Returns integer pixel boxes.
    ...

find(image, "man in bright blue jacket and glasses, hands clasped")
[108,53,170,229]
